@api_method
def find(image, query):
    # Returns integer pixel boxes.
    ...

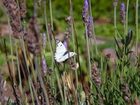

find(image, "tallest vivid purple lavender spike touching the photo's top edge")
[82,0,89,23]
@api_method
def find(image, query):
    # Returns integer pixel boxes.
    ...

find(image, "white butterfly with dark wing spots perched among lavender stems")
[55,41,76,63]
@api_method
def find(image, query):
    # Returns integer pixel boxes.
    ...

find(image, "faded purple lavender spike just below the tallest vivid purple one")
[87,16,93,38]
